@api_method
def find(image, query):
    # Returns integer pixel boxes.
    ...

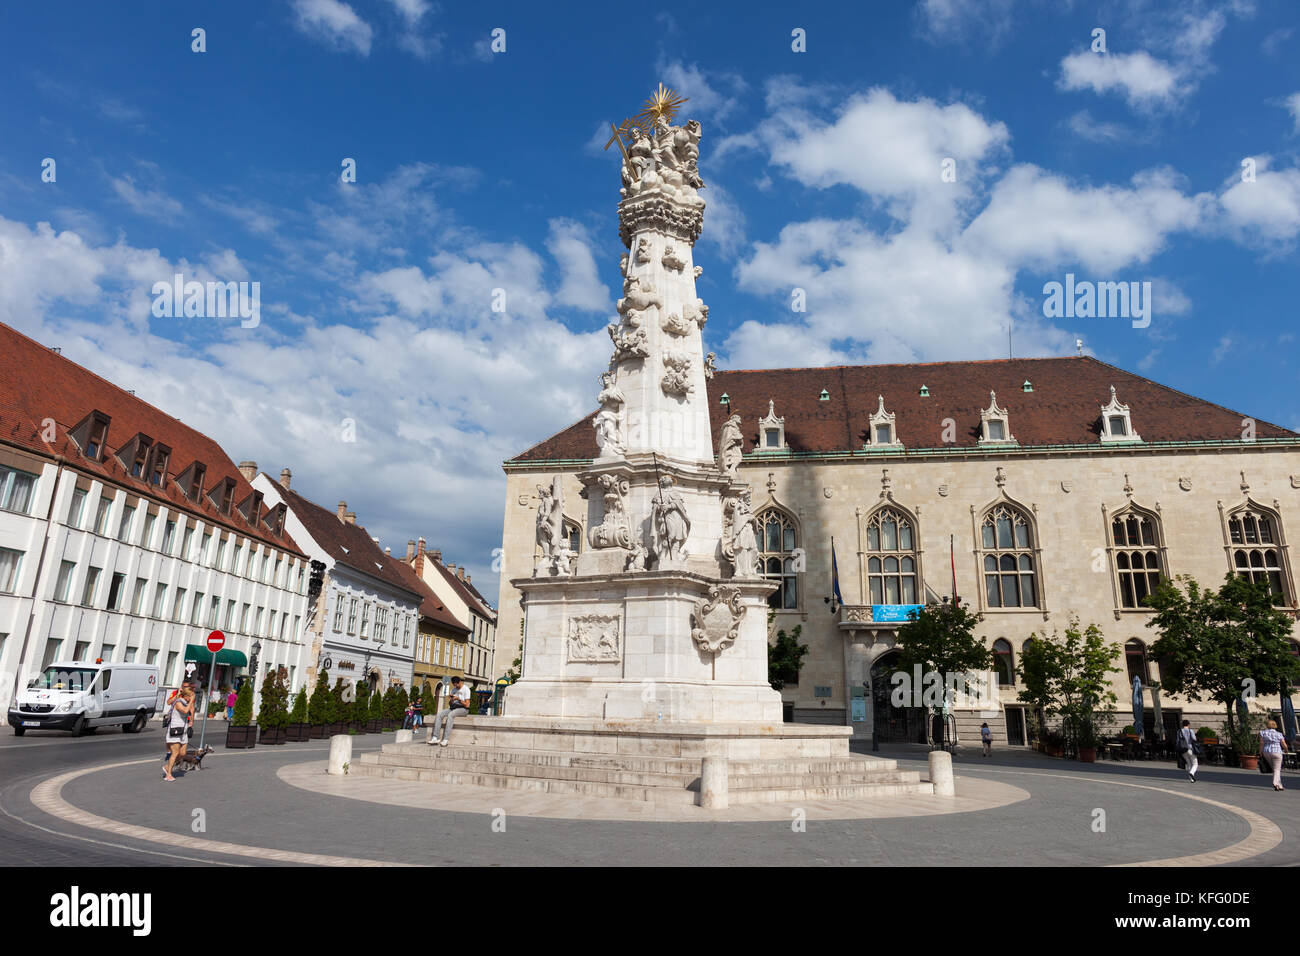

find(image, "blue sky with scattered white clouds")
[0,0,1300,597]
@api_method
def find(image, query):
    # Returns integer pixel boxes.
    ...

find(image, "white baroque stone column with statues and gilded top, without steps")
[506,86,781,724]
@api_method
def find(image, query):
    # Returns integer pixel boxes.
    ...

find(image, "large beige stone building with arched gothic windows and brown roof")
[499,356,1300,744]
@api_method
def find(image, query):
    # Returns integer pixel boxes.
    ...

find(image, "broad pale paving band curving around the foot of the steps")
[278,761,1030,823]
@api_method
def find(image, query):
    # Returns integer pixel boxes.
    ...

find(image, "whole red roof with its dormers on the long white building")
[0,323,300,554]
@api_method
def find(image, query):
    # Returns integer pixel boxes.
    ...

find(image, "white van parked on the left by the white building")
[9,661,159,737]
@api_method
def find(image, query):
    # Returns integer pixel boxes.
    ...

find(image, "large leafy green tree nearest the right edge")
[1147,574,1300,737]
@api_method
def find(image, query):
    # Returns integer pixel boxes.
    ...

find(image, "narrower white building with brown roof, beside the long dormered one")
[249,473,425,691]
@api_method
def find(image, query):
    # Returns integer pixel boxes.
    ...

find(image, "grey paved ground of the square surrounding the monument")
[0,734,1300,866]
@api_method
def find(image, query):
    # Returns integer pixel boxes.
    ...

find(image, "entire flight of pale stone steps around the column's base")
[351,743,933,804]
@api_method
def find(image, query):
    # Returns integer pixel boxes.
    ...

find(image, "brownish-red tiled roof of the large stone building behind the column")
[507,355,1300,464]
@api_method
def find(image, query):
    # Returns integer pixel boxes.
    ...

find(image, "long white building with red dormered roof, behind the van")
[0,325,308,712]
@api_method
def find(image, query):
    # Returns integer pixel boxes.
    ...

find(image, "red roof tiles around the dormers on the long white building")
[0,323,306,557]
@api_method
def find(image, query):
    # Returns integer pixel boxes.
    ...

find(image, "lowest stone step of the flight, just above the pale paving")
[354,754,933,805]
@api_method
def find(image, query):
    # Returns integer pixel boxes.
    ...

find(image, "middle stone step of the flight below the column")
[361,748,920,790]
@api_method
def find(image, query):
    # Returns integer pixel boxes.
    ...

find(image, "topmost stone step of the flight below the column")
[381,744,898,777]
